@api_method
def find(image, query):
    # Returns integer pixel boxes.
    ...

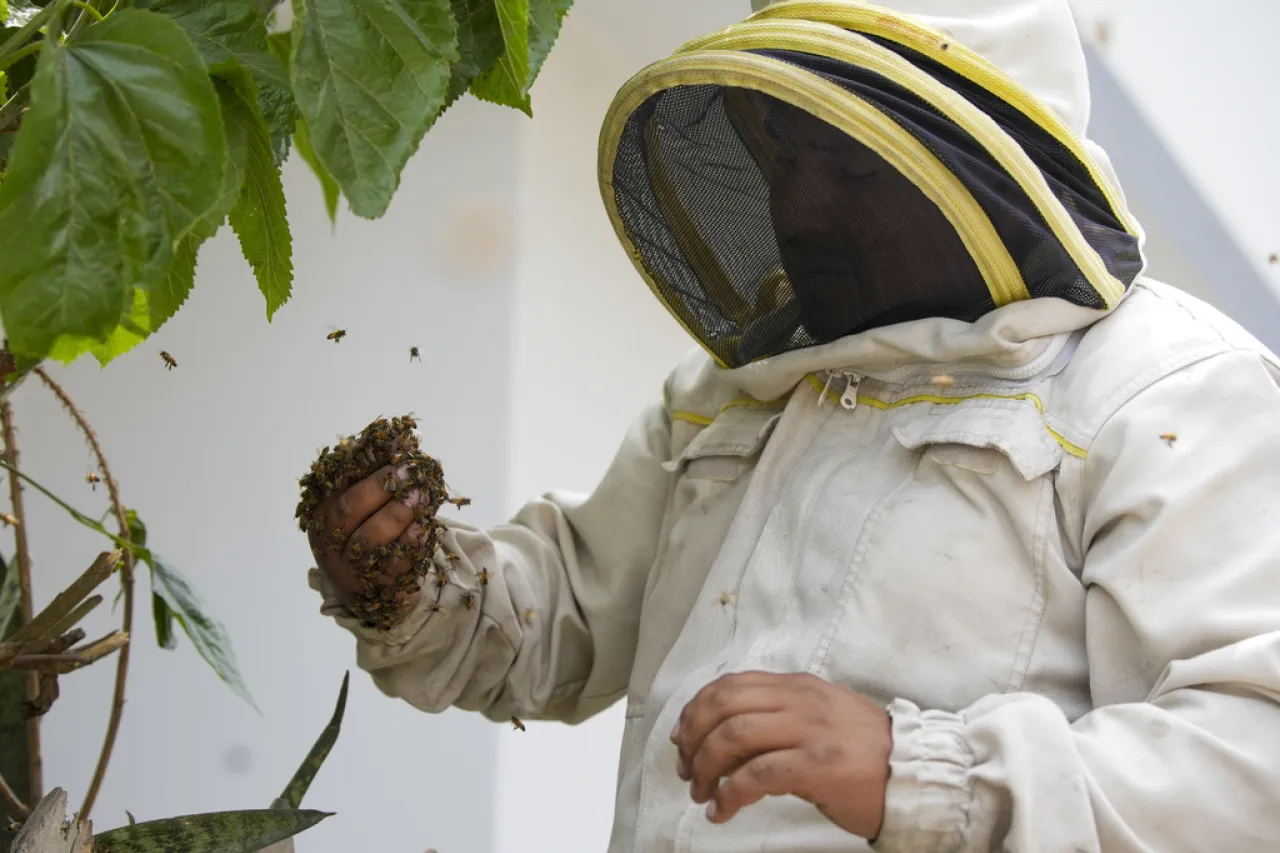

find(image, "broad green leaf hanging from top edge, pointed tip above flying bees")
[291,0,458,219]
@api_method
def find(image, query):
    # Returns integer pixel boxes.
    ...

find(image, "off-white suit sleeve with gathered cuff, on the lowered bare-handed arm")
[874,352,1280,853]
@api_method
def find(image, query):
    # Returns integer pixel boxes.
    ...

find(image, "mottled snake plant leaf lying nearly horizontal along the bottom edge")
[93,808,333,853]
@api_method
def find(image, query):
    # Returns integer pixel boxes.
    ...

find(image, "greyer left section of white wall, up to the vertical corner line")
[10,89,520,853]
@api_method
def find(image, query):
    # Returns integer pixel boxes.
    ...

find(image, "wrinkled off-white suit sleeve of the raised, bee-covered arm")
[310,405,671,722]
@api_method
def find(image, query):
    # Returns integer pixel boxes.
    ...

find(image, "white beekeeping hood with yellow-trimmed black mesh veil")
[599,0,1144,392]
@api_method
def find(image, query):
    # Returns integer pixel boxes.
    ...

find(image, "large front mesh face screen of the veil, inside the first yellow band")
[613,86,995,366]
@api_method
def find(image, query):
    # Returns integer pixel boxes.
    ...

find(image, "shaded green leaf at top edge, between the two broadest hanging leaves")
[136,0,298,165]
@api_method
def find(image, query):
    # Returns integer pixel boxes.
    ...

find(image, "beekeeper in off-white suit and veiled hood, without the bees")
[310,0,1280,853]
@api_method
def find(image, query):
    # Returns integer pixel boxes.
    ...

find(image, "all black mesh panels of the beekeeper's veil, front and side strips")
[612,51,1142,366]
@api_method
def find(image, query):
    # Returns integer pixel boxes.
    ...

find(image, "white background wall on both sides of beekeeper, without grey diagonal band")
[0,0,1280,853]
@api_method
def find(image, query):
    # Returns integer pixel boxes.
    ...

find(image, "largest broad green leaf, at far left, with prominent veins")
[0,9,227,357]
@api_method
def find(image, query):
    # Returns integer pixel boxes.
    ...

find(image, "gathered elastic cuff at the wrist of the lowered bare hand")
[872,699,973,853]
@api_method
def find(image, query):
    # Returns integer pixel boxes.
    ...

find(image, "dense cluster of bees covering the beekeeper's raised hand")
[294,415,474,630]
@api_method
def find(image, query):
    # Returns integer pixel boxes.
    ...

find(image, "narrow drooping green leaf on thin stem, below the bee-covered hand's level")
[125,510,257,711]
